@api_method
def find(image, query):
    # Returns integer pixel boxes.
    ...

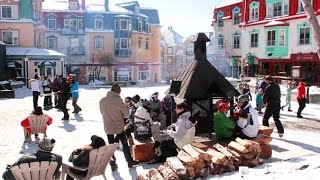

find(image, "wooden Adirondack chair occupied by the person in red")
[23,115,49,142]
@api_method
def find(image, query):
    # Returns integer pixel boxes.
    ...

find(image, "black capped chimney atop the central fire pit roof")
[194,33,210,61]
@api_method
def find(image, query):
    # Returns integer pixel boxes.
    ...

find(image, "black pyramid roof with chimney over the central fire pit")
[176,33,240,99]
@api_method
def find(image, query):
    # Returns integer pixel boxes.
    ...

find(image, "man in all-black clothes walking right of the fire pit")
[262,76,284,138]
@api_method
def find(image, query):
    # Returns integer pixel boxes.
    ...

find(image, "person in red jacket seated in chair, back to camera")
[21,106,52,142]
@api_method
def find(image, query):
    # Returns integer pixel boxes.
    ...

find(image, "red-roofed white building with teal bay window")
[212,0,320,86]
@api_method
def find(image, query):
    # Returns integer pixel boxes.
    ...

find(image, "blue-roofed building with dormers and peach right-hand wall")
[43,0,161,84]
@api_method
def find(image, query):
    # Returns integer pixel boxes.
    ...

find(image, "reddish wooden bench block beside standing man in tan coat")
[131,133,155,162]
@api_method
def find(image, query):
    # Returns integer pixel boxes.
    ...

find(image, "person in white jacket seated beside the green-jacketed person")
[235,95,259,139]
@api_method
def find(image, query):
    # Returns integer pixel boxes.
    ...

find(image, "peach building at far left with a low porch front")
[0,0,66,81]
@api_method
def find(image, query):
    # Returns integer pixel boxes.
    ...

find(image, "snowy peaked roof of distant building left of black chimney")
[162,27,183,46]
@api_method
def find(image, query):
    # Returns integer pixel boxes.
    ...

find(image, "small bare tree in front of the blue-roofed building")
[90,51,114,80]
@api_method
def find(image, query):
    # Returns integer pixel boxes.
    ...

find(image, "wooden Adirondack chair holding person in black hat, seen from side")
[61,143,118,180]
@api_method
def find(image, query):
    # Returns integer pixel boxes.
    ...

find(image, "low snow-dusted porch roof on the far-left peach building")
[7,47,65,56]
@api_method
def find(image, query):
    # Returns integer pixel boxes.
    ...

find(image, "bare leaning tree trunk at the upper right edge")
[300,0,320,58]
